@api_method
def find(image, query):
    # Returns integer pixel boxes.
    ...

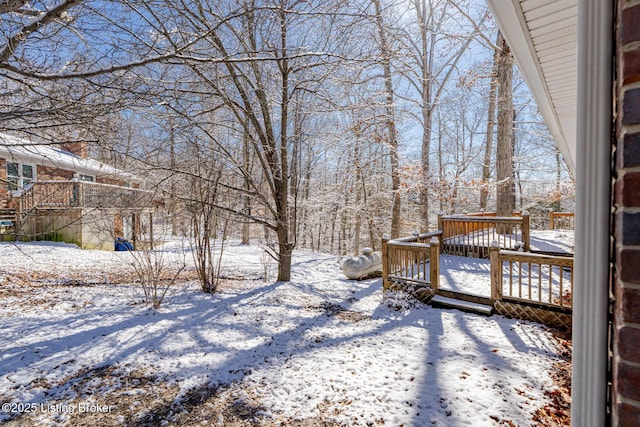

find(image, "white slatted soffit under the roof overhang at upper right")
[487,0,578,174]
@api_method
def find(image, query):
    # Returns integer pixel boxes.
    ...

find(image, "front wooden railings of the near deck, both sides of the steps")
[382,229,574,328]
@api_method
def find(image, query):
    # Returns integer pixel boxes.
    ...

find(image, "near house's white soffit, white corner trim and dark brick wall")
[488,0,640,427]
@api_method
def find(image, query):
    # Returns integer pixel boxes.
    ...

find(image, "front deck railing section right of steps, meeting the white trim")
[490,243,573,310]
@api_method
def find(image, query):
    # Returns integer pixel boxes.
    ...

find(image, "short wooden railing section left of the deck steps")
[382,231,441,290]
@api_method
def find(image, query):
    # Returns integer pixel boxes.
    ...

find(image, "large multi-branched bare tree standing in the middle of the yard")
[134,0,352,281]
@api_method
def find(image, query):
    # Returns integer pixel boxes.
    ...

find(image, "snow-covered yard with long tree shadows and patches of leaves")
[0,239,562,426]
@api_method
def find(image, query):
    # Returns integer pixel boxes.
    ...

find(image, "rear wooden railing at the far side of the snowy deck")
[438,211,531,258]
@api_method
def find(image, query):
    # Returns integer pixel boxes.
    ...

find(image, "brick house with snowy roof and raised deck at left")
[0,134,152,250]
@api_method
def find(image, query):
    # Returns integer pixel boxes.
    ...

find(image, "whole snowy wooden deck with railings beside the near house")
[382,215,573,329]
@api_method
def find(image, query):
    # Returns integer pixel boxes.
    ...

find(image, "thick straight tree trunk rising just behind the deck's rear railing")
[496,31,514,216]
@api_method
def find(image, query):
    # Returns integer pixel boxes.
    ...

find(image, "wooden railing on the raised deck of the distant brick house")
[19,181,153,212]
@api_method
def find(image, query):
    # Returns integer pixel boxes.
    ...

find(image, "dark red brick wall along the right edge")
[611,0,640,426]
